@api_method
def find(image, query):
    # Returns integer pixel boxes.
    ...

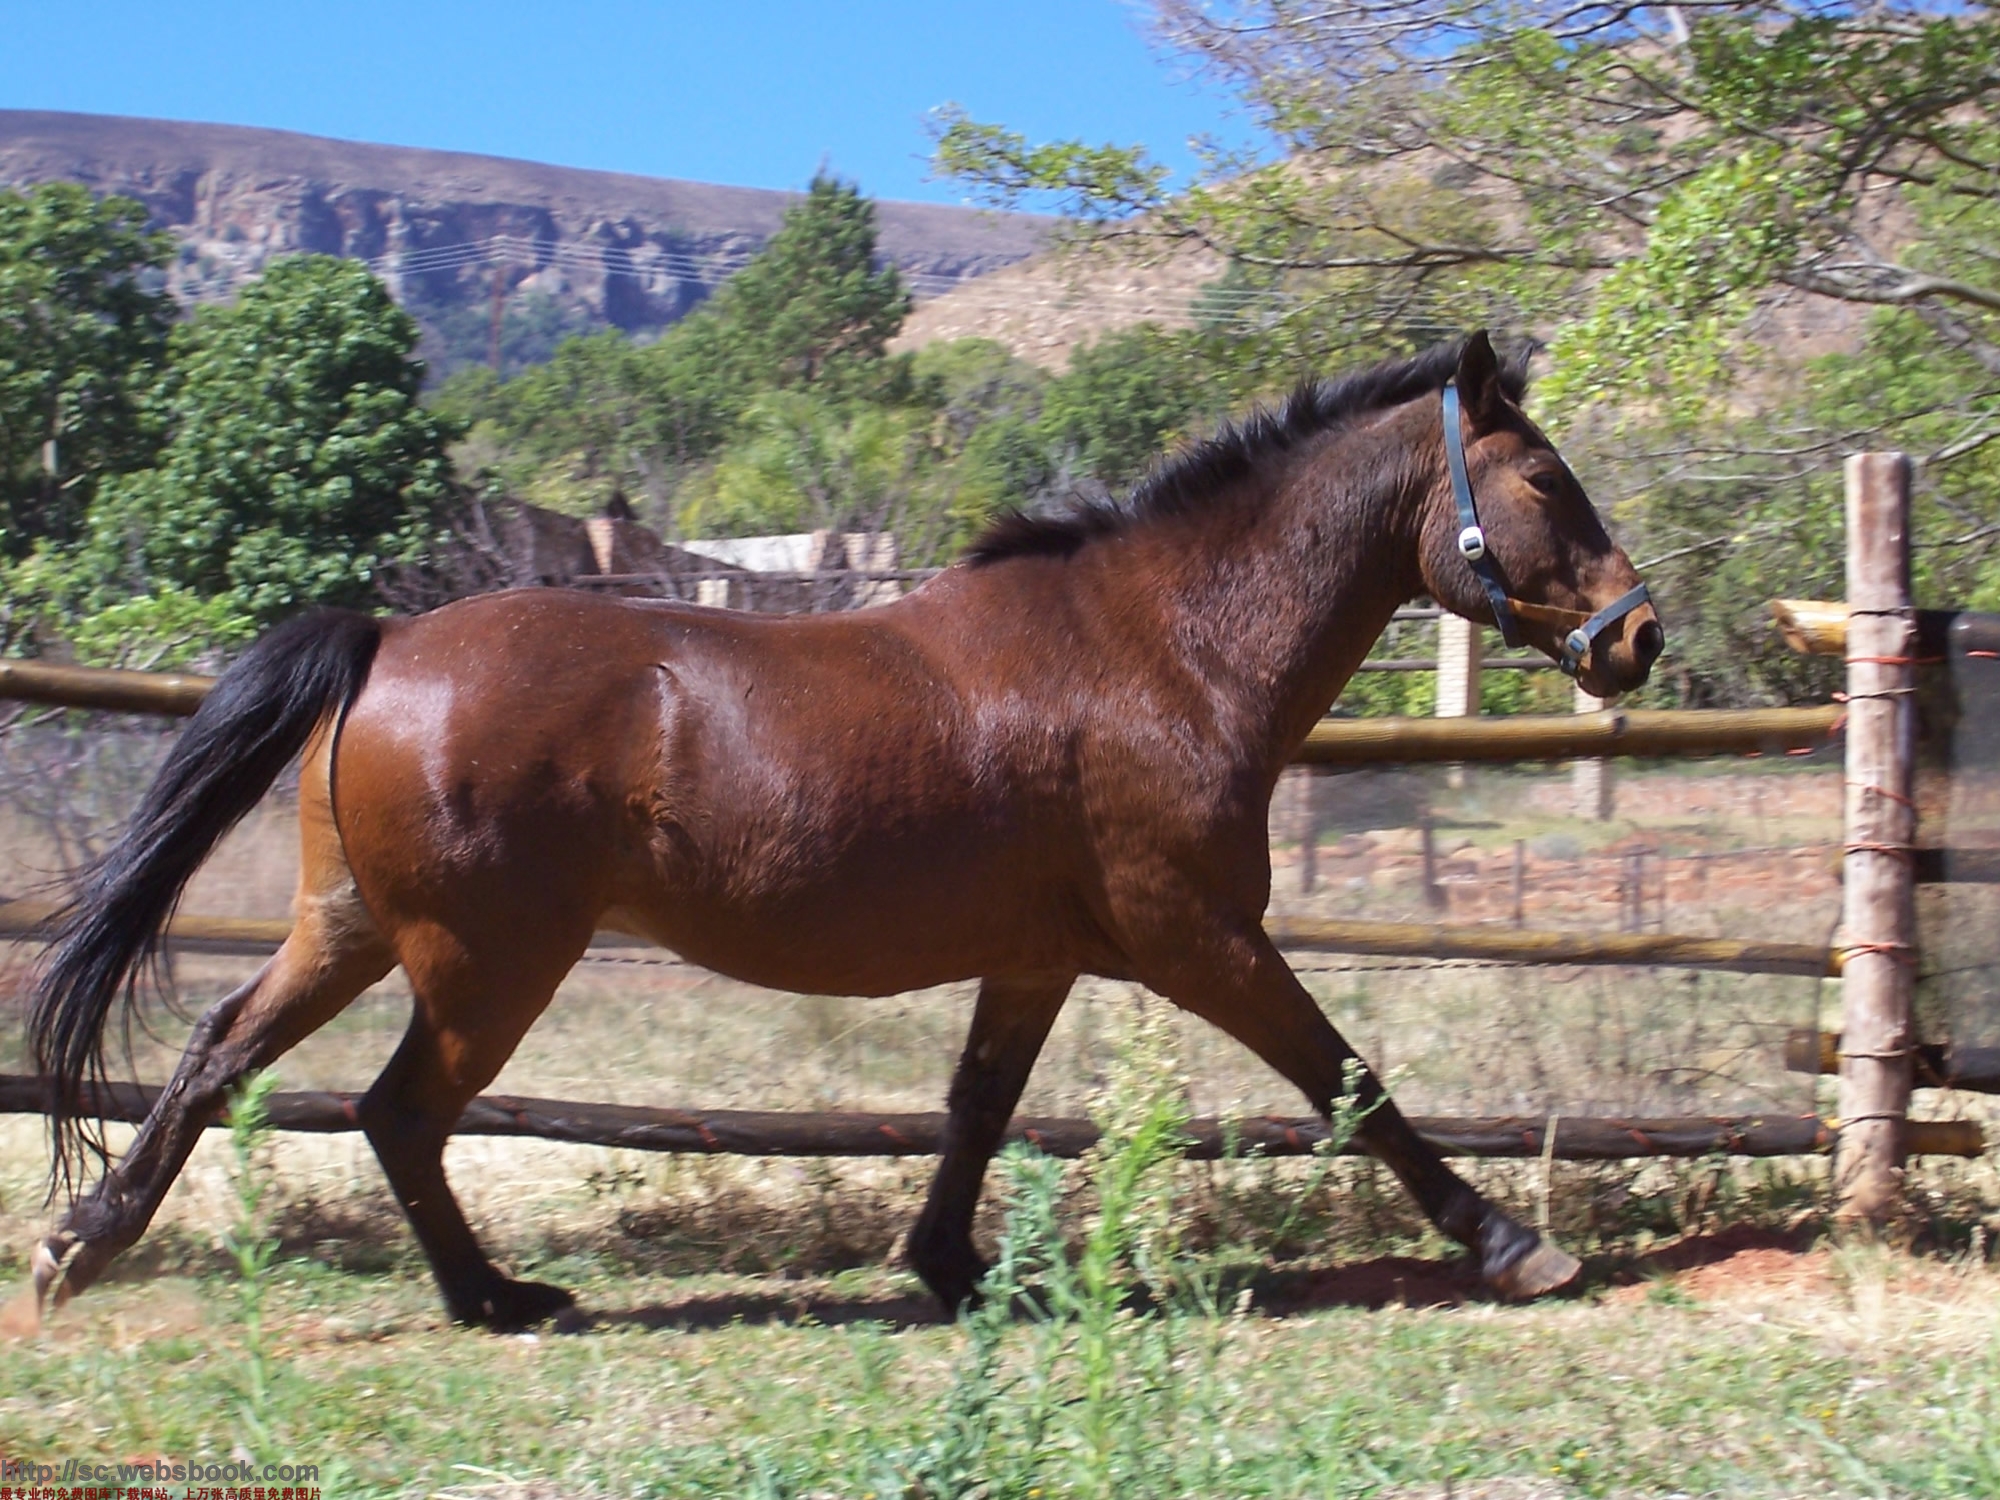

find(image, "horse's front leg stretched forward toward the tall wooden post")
[1154,924,1582,1298]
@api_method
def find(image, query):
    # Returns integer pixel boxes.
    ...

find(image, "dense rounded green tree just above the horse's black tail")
[74,256,456,652]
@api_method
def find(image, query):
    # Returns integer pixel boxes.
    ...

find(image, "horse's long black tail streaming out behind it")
[28,610,382,1190]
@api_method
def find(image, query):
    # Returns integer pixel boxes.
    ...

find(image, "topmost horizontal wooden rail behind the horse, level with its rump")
[0,662,1844,766]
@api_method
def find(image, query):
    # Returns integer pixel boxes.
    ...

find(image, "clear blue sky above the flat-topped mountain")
[0,0,1242,202]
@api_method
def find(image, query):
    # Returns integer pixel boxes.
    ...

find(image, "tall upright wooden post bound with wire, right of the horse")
[1834,454,1916,1224]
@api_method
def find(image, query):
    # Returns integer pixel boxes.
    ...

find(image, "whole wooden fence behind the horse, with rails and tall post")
[0,456,1984,1192]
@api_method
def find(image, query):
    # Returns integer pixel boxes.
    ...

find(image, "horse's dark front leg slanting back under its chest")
[908,978,1072,1312]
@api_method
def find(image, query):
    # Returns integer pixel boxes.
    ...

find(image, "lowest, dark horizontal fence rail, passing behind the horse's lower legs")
[0,1074,1986,1162]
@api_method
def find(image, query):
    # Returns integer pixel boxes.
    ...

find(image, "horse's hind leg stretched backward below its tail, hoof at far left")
[34,904,394,1304]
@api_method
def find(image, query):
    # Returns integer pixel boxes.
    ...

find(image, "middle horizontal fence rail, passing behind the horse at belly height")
[0,900,1840,978]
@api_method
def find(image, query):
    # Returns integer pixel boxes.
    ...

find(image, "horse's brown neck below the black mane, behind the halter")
[1120,428,1428,774]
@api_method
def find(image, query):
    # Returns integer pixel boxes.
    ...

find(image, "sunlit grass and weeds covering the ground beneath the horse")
[11,1008,2000,1500]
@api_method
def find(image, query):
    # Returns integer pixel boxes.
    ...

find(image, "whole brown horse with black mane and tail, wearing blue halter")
[32,334,1662,1328]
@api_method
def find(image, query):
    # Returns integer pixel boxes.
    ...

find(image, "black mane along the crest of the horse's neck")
[966,340,1532,566]
